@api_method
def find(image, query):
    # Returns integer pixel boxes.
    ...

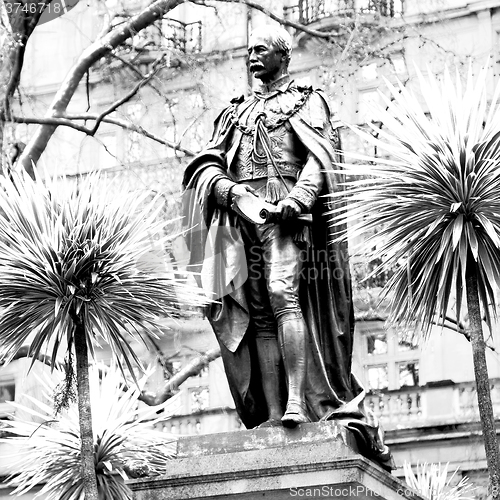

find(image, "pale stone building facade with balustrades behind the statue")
[0,0,500,498]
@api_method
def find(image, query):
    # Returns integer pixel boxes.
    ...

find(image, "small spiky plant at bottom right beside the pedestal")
[403,462,475,500]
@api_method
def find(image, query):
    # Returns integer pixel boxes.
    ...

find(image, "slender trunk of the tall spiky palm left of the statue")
[75,318,99,500]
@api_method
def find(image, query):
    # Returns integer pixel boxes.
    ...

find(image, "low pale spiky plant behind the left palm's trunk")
[1,367,176,500]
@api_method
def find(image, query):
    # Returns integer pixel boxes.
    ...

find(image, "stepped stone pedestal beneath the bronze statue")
[127,422,421,500]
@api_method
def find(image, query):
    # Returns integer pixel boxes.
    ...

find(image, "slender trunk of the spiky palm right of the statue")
[465,256,500,498]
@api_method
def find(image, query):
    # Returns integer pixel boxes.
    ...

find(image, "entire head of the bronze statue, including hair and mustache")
[248,26,292,83]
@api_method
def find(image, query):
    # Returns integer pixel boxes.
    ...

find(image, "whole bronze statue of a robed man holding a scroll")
[184,26,390,468]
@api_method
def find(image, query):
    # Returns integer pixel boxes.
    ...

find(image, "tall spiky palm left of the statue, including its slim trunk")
[0,170,205,500]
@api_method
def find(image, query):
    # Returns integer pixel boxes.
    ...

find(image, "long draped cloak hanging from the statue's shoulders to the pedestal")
[183,84,392,469]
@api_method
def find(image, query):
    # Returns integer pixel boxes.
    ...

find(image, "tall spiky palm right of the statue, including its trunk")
[332,68,500,498]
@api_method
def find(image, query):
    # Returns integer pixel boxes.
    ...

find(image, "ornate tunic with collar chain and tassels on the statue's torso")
[214,76,330,212]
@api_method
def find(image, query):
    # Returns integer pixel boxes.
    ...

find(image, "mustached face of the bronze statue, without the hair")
[248,35,286,83]
